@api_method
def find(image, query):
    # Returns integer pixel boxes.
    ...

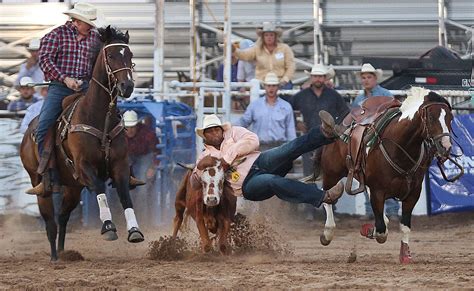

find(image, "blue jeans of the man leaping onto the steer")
[242,127,334,207]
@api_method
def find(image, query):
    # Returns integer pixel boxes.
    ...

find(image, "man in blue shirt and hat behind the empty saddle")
[352,64,393,105]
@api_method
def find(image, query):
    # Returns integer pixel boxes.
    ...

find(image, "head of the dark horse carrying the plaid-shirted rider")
[99,26,134,98]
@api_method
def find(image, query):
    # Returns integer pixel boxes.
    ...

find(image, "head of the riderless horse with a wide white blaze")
[419,92,453,162]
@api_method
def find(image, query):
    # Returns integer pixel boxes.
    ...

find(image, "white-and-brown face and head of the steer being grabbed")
[198,156,225,207]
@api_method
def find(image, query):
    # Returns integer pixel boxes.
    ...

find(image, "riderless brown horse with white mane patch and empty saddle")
[321,88,462,263]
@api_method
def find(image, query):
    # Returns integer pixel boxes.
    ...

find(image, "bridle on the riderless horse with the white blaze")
[420,102,464,182]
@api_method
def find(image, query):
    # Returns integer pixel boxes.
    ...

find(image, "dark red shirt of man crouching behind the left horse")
[127,124,161,165]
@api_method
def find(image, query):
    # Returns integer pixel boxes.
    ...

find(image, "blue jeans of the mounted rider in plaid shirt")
[36,81,89,156]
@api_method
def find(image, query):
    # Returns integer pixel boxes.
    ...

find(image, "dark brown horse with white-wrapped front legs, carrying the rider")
[20,27,144,261]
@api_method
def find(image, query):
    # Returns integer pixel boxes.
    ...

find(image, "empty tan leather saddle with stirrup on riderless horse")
[343,96,401,195]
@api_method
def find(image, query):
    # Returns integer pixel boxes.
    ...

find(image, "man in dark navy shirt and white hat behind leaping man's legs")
[288,64,349,177]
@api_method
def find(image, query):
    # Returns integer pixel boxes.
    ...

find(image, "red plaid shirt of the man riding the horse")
[39,21,99,82]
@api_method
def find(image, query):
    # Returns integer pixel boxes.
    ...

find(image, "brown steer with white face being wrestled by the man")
[173,156,237,255]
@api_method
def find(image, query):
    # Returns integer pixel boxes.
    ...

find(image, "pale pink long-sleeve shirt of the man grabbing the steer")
[193,126,260,196]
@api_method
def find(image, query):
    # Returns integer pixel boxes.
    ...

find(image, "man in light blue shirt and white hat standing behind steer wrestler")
[236,72,296,151]
